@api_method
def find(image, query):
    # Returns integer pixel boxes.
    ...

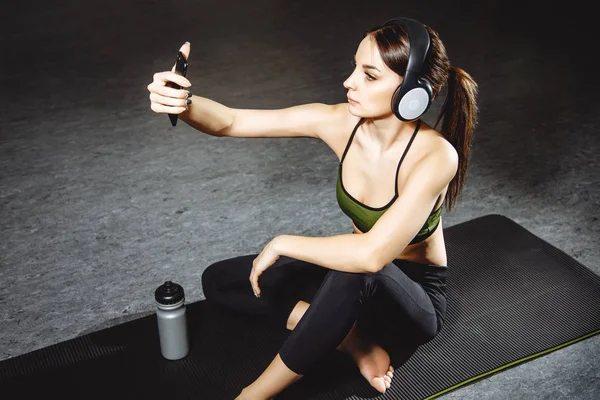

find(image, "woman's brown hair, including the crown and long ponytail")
[364,24,478,210]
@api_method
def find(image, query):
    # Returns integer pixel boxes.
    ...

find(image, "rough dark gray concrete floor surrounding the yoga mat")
[0,0,600,400]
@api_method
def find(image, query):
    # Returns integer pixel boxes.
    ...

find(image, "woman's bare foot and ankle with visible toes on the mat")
[338,327,394,393]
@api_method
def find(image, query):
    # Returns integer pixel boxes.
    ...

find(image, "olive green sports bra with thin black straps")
[336,118,443,244]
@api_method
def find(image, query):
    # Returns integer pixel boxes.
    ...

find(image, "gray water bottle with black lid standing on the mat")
[154,281,189,360]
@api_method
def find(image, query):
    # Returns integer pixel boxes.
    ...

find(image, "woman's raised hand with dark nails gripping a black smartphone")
[147,42,192,126]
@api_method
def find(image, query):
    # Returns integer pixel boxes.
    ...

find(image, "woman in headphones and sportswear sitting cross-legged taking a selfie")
[148,19,477,400]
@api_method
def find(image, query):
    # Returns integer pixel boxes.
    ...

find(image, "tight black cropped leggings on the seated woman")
[202,254,447,375]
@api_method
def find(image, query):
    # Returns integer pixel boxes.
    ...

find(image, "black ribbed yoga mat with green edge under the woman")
[0,214,600,400]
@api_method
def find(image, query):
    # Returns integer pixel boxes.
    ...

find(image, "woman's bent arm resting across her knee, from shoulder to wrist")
[273,143,458,273]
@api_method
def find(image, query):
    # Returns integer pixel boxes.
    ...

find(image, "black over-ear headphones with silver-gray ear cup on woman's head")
[383,18,433,121]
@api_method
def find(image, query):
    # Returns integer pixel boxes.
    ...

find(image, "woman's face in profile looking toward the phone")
[344,36,402,118]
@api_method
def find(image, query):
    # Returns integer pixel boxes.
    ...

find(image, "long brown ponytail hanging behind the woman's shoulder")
[434,66,478,211]
